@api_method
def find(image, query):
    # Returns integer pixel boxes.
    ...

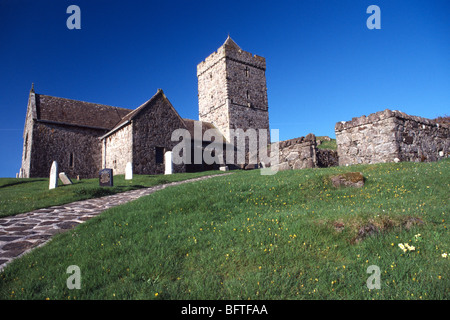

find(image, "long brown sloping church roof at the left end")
[35,93,132,130]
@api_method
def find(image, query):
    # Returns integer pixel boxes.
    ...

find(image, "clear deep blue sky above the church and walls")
[0,0,450,177]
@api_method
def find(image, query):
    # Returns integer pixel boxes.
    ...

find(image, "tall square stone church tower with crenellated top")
[197,36,270,150]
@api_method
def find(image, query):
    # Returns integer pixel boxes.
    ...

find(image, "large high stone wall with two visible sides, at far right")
[335,109,450,165]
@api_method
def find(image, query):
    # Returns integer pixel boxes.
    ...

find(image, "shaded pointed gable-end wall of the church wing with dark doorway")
[132,92,186,174]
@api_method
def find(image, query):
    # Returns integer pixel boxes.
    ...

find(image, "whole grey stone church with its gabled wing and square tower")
[20,37,270,178]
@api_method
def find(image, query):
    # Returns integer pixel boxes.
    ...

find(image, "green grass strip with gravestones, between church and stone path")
[0,171,222,218]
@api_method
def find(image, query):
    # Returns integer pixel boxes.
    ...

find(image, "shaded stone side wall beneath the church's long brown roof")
[30,121,105,178]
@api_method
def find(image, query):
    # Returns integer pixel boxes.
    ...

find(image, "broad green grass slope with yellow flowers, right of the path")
[0,160,450,300]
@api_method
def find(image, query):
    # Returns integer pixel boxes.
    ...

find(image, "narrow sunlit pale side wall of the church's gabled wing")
[102,123,133,174]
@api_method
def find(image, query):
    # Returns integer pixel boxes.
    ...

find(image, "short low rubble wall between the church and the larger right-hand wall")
[274,133,318,171]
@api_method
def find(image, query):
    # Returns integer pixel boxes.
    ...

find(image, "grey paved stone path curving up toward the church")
[0,173,229,271]
